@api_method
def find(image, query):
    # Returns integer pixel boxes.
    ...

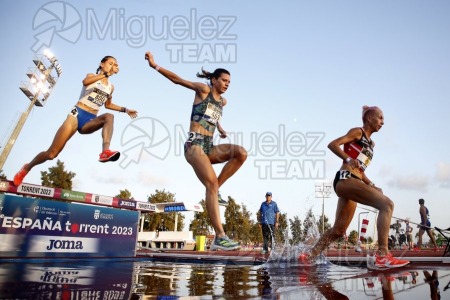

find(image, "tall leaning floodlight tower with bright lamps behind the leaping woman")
[0,50,62,170]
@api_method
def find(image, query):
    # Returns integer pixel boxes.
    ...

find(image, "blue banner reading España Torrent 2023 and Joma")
[0,195,139,257]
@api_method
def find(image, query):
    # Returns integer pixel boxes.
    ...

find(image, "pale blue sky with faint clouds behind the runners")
[0,0,450,243]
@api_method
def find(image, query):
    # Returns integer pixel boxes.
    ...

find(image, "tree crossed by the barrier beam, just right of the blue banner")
[144,190,184,231]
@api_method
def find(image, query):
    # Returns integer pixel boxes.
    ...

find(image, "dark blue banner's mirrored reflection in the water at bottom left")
[0,259,133,299]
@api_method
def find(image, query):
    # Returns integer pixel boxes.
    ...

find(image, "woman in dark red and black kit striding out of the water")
[299,106,409,268]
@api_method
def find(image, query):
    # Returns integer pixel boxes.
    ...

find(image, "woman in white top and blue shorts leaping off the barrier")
[14,56,137,186]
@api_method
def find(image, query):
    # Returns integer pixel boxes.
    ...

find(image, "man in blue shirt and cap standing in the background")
[259,192,280,254]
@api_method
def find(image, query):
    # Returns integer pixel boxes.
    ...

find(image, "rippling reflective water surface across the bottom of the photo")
[0,259,450,300]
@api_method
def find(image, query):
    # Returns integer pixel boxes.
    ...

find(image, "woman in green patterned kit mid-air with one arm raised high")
[145,52,247,250]
